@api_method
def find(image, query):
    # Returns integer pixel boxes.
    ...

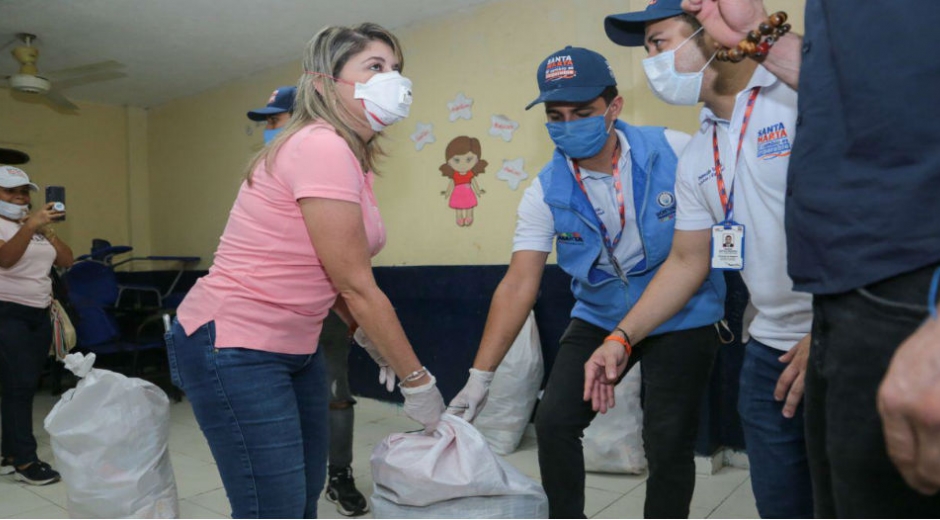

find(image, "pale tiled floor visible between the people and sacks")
[0,392,757,518]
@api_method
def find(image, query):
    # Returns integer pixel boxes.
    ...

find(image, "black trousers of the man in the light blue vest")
[535,319,719,518]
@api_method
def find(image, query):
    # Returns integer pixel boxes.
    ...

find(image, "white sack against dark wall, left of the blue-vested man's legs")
[473,311,545,455]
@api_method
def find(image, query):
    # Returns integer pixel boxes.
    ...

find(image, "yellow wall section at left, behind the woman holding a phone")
[0,90,132,256]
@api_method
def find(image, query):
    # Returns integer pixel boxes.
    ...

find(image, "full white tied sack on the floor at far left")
[44,354,179,518]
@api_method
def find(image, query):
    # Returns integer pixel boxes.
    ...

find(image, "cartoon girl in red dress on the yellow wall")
[440,135,487,227]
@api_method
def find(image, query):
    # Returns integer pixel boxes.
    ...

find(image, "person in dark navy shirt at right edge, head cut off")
[683,0,940,518]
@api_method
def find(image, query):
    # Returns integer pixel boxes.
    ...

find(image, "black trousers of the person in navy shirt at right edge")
[805,267,940,518]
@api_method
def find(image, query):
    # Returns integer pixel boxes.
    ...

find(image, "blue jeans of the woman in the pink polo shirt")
[166,321,329,518]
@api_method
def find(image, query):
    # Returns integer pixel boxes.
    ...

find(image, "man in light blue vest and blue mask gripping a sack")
[449,47,725,518]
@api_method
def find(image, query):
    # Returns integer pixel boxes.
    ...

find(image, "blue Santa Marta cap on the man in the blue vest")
[525,45,617,110]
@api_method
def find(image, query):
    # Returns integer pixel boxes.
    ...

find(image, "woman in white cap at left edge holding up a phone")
[0,166,73,486]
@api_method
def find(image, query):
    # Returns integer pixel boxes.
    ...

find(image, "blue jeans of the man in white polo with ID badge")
[738,339,813,518]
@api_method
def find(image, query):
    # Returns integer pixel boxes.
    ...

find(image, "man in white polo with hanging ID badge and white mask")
[585,0,813,518]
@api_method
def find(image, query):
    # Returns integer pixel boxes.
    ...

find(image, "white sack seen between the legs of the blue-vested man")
[583,363,646,474]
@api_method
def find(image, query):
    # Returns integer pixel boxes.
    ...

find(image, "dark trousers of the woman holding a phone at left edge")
[0,301,52,465]
